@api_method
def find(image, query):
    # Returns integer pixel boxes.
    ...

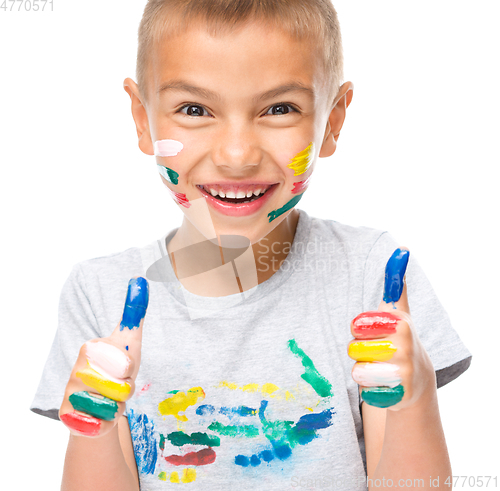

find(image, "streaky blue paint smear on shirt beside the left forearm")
[127,409,158,474]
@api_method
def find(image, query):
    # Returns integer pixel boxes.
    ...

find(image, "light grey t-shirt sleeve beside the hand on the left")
[30,264,101,419]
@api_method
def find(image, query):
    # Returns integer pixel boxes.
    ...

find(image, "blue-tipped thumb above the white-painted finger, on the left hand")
[109,277,149,361]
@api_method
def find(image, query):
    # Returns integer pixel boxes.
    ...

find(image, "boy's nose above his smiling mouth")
[212,121,262,173]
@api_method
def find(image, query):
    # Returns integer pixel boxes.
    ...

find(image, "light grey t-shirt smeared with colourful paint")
[31,210,471,491]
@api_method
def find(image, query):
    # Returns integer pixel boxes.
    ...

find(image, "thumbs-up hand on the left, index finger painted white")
[59,277,149,437]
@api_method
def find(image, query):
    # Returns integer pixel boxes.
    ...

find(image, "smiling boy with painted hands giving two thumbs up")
[32,0,470,490]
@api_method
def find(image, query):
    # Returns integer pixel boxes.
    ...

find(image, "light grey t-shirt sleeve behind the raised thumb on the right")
[363,232,471,387]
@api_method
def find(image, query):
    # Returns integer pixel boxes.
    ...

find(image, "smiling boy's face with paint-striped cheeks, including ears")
[125,23,352,243]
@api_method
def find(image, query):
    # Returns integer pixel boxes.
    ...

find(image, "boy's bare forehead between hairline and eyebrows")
[149,22,324,103]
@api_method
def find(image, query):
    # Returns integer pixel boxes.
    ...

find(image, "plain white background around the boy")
[0,0,500,491]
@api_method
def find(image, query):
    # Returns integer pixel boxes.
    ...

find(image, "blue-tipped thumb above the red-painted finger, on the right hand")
[378,247,410,314]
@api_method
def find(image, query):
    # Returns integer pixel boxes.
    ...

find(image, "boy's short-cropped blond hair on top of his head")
[136,0,344,102]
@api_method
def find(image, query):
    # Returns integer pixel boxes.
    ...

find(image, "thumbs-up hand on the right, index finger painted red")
[348,248,435,411]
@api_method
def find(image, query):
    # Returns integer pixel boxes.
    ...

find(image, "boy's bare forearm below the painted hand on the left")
[61,417,139,491]
